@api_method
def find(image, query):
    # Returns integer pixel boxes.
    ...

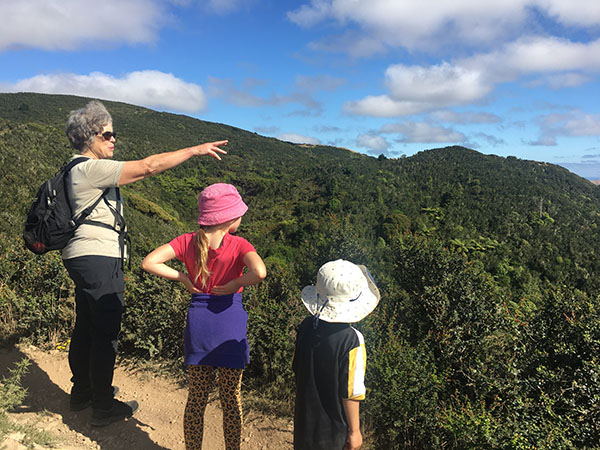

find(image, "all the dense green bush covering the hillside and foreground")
[0,94,600,449]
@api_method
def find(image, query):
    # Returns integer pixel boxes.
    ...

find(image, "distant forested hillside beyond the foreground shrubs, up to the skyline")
[0,94,600,286]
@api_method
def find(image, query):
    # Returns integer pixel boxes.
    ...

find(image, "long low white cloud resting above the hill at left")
[2,70,206,113]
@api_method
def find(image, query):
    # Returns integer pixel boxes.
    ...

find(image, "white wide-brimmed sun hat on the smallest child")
[300,259,380,323]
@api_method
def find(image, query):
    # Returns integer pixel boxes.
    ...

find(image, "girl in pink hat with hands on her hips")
[142,183,266,450]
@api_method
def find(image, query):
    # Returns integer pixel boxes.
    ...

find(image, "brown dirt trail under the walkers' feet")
[0,346,292,450]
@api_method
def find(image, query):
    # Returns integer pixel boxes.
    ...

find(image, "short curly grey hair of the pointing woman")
[65,100,112,152]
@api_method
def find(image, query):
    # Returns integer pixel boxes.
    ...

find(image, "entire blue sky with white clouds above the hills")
[0,0,600,179]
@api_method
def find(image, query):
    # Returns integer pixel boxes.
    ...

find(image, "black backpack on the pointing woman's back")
[23,158,108,255]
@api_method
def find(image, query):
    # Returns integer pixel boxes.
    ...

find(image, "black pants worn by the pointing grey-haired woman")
[64,256,125,409]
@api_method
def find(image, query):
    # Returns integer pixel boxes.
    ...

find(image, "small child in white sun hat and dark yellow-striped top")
[292,259,380,450]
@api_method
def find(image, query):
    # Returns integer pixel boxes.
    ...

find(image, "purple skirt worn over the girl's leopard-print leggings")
[184,294,250,369]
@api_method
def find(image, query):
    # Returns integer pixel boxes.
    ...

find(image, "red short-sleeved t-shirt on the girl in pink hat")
[169,233,256,293]
